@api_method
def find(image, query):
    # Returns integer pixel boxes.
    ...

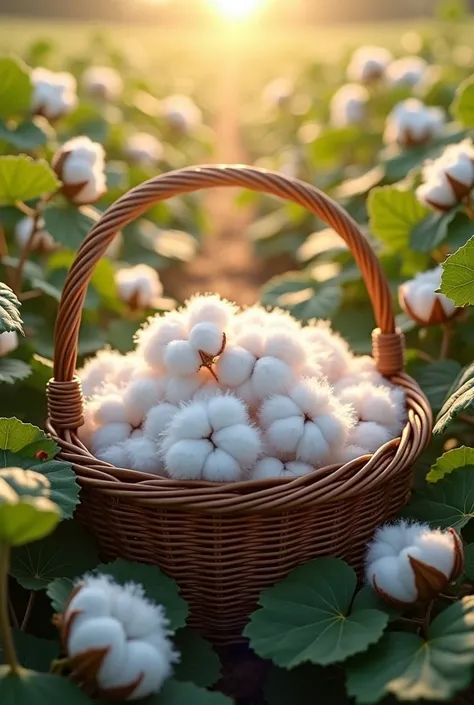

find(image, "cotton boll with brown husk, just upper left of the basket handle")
[52,137,107,205]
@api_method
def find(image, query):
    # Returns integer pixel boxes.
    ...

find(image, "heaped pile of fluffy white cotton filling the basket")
[79,295,406,482]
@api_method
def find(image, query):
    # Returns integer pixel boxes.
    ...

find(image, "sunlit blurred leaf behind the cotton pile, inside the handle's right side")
[260,272,342,322]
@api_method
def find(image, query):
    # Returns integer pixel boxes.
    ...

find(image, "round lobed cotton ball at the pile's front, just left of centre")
[162,394,262,482]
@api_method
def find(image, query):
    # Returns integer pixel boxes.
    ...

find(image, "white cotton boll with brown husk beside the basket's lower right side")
[366,520,463,606]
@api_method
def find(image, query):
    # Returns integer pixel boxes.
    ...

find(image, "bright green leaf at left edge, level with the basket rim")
[0,417,59,467]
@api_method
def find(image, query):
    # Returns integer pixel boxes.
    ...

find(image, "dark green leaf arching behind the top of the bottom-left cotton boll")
[97,559,188,630]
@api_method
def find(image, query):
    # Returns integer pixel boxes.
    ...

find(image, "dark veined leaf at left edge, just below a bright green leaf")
[0,452,80,519]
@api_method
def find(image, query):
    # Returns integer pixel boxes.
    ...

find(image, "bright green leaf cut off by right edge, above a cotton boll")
[440,236,474,306]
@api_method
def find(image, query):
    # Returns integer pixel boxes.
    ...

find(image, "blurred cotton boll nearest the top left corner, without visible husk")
[30,67,77,120]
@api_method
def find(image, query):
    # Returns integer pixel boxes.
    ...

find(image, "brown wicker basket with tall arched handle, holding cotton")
[48,166,432,643]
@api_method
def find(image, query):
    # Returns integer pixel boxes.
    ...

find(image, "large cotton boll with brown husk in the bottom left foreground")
[55,575,180,701]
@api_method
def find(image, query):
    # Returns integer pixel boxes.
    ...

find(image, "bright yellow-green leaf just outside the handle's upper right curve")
[368,186,429,252]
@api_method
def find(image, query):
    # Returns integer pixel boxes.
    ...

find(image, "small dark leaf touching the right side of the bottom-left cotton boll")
[173,627,221,688]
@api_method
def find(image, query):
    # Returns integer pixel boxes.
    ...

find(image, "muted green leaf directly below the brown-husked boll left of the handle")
[43,203,100,250]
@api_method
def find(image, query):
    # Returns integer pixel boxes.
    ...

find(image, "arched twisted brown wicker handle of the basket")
[48,165,404,429]
